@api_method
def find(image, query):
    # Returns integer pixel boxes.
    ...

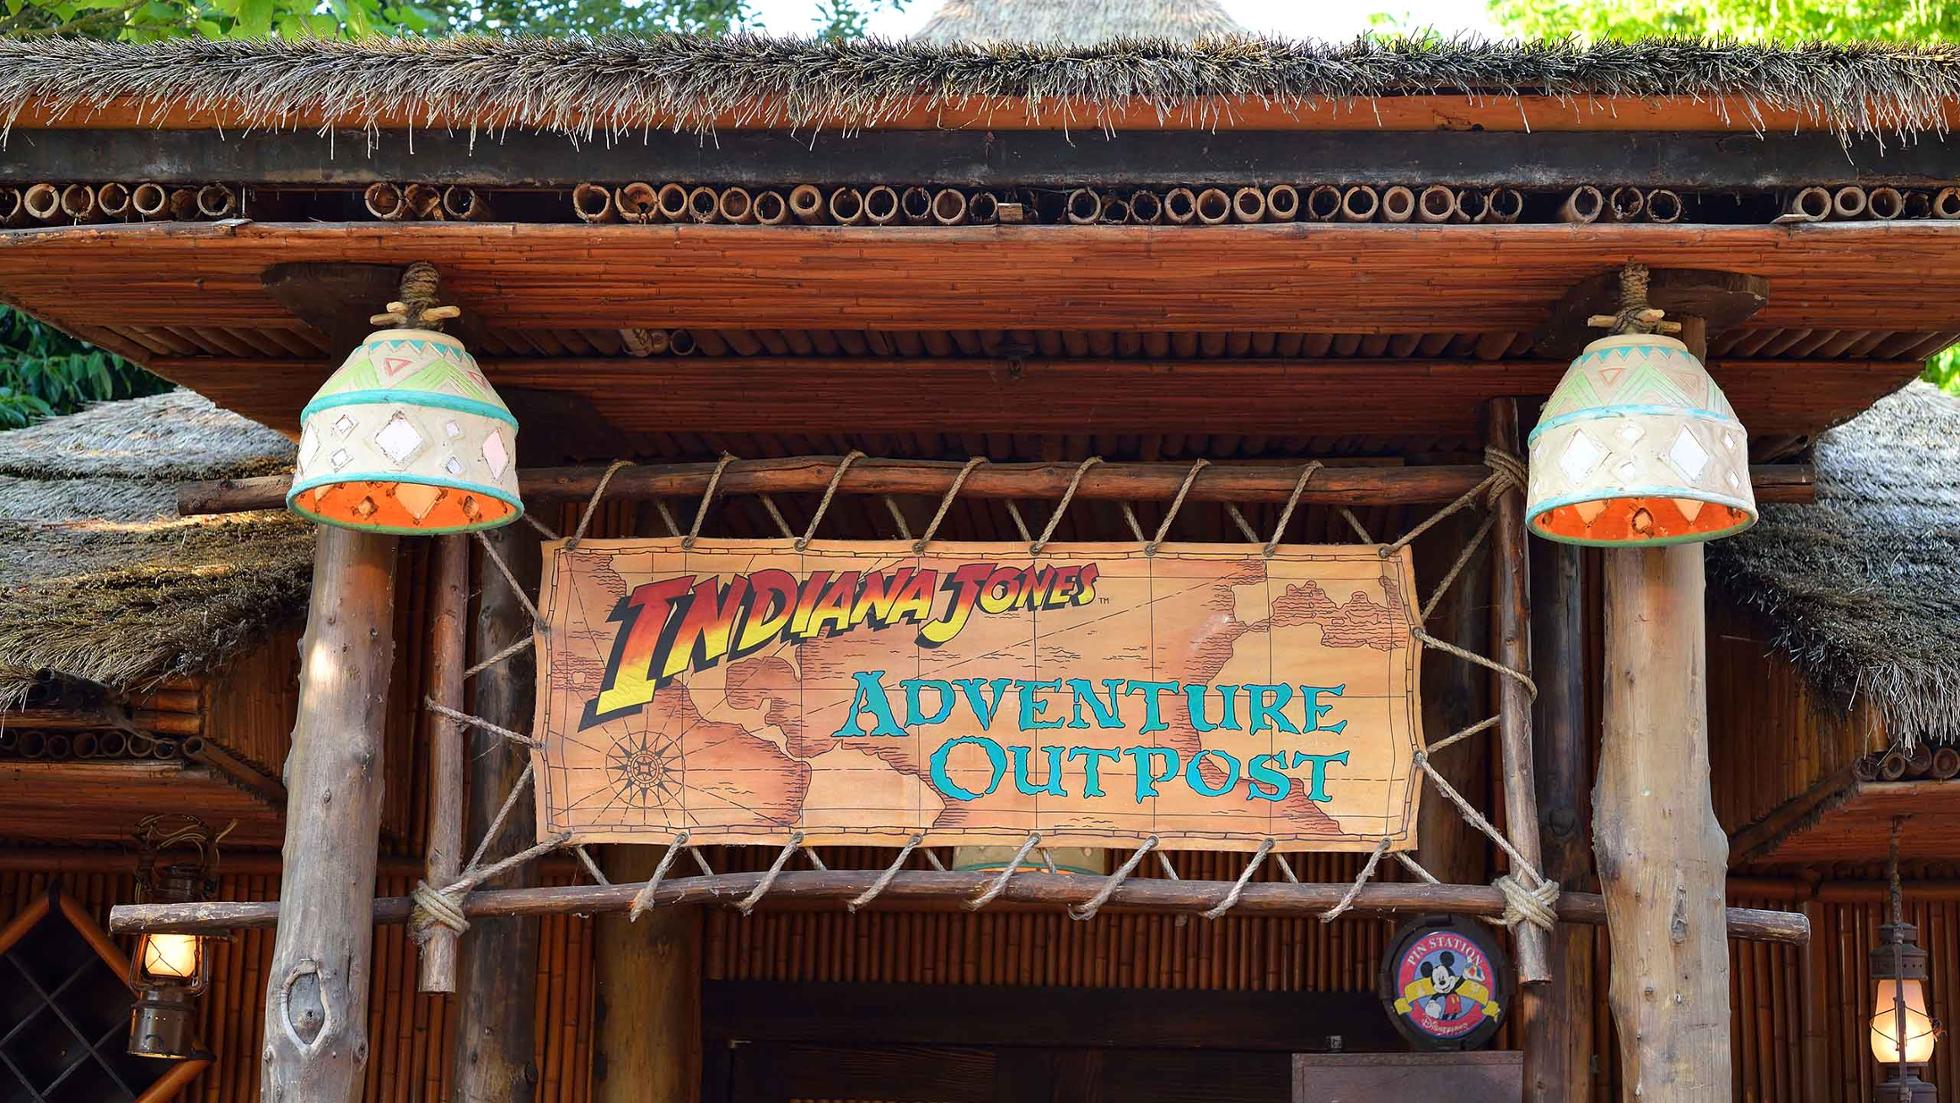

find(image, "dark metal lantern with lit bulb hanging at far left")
[129,815,223,1058]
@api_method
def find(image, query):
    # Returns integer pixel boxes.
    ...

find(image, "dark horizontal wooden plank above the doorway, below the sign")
[702,982,1399,1052]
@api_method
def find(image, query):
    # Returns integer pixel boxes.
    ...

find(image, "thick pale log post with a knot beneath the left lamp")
[261,525,396,1103]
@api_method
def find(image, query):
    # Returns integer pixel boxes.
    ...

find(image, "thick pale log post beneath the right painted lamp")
[1593,317,1733,1103]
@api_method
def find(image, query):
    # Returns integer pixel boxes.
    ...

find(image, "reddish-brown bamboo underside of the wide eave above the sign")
[0,221,1960,447]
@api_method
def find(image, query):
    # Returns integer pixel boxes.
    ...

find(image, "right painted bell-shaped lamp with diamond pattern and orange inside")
[1525,333,1756,547]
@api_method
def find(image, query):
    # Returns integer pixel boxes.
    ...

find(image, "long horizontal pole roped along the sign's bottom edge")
[110,870,1809,944]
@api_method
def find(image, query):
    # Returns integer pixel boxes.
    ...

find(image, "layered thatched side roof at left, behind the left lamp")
[0,392,314,707]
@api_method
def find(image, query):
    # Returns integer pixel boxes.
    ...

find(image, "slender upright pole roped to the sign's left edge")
[421,537,470,991]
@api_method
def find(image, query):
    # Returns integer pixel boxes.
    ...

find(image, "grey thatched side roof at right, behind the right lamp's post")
[1709,382,1960,743]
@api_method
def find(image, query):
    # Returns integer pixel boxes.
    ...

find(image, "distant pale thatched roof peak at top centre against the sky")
[913,0,1245,45]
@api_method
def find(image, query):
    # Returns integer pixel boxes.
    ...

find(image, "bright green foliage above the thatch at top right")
[1490,0,1960,43]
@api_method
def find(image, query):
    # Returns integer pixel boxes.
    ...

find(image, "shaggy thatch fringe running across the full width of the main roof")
[0,35,1960,135]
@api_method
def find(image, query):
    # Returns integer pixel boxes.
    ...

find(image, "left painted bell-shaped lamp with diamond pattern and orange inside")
[286,329,523,535]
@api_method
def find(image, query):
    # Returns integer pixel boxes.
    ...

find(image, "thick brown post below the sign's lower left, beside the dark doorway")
[592,846,702,1103]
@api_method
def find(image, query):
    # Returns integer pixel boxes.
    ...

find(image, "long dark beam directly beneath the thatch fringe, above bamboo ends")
[0,125,1960,190]
